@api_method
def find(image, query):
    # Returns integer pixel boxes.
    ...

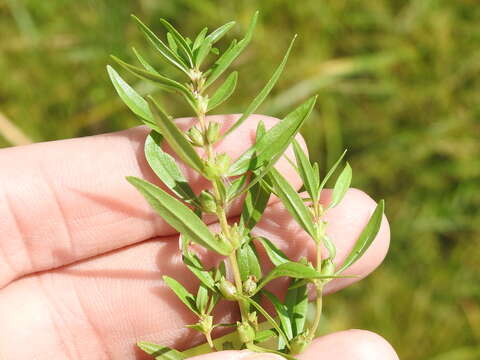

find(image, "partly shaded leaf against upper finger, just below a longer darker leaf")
[144,131,198,204]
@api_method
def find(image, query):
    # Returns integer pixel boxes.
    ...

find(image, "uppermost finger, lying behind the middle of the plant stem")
[0,115,298,287]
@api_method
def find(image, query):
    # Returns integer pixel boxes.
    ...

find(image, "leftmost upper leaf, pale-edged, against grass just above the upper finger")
[107,65,158,129]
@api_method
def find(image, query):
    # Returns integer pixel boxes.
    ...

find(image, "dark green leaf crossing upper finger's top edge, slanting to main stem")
[147,96,203,172]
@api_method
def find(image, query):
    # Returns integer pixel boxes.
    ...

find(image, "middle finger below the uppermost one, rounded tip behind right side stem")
[0,190,389,359]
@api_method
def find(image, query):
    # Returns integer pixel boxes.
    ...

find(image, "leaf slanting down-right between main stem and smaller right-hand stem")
[268,168,316,238]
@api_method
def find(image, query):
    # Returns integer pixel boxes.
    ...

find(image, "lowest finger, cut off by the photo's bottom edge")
[189,330,398,360]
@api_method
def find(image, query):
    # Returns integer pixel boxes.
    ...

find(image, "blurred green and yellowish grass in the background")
[0,0,480,360]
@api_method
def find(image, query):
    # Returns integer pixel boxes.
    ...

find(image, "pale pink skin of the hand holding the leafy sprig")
[0,115,398,360]
